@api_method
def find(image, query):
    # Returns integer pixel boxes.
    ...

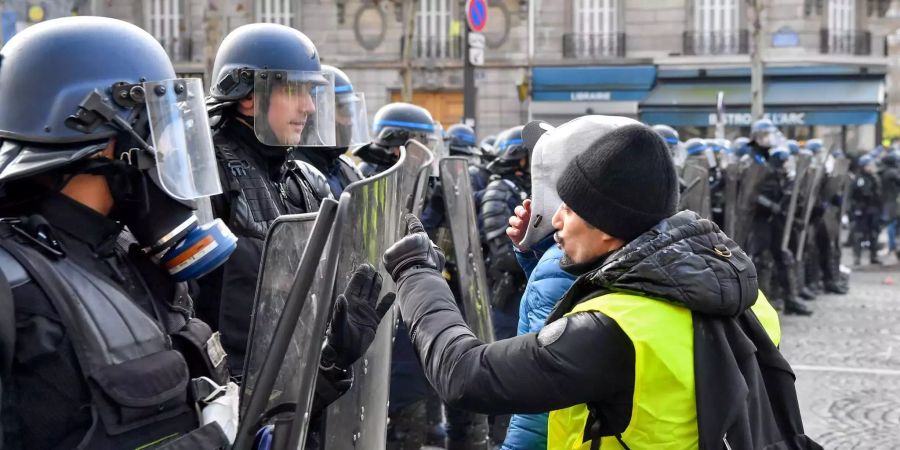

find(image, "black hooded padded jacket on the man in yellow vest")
[398,211,820,448]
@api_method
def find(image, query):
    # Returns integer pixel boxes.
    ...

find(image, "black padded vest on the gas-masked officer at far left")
[0,223,228,449]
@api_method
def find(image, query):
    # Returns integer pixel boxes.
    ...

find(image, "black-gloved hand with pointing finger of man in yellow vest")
[382,214,446,284]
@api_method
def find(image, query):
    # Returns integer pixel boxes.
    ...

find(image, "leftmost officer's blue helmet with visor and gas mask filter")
[0,17,236,280]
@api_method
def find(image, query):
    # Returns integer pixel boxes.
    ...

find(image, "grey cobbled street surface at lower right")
[782,258,900,449]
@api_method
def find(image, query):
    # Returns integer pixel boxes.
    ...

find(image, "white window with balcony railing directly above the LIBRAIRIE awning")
[563,0,625,58]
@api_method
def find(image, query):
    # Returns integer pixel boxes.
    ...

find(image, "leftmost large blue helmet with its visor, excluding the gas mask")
[0,17,221,199]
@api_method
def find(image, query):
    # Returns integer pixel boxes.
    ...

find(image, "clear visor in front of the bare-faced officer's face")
[253,70,335,147]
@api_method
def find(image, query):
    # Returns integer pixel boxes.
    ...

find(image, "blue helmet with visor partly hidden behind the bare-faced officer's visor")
[322,64,369,151]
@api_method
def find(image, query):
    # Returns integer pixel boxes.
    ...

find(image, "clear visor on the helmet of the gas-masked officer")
[144,78,222,200]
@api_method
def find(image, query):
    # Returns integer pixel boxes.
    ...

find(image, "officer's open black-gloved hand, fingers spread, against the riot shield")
[322,264,395,370]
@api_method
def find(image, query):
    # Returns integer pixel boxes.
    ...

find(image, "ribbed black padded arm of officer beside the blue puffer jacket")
[479,178,528,309]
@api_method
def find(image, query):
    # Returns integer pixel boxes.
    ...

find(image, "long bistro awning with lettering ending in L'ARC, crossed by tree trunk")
[640,78,885,126]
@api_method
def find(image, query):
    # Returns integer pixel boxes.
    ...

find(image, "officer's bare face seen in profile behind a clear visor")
[267,83,316,145]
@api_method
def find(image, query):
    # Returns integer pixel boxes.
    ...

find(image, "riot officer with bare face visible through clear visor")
[200,24,336,375]
